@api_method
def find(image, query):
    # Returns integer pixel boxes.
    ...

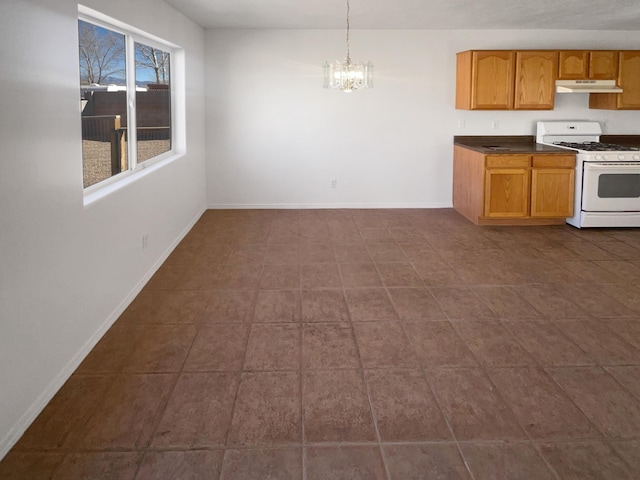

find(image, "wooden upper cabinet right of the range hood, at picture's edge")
[589,50,640,110]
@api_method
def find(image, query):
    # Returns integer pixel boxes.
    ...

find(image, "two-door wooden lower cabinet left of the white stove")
[453,145,575,225]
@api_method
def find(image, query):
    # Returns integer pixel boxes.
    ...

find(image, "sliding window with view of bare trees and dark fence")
[78,9,174,191]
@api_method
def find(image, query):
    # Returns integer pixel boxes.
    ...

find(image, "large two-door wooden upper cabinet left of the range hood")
[456,50,558,110]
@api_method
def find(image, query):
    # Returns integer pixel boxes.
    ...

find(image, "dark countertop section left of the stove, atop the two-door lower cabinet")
[453,135,574,155]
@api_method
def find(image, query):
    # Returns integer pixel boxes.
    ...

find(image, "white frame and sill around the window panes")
[78,5,186,202]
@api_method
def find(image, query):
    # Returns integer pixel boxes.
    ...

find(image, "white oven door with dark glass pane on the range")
[582,162,640,212]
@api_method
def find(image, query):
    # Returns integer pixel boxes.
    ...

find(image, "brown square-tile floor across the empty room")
[0,209,640,480]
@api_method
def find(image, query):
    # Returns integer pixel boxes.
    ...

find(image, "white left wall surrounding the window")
[0,0,206,458]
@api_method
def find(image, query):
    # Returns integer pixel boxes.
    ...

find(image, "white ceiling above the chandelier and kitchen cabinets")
[166,0,640,31]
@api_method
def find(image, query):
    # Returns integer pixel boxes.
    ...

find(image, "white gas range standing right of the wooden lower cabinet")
[536,121,640,228]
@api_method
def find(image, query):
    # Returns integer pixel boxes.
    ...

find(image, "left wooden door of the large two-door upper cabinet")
[471,51,515,110]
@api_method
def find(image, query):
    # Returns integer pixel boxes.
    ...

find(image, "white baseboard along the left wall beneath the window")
[0,209,205,460]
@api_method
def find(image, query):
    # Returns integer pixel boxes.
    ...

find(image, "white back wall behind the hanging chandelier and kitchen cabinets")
[206,30,640,207]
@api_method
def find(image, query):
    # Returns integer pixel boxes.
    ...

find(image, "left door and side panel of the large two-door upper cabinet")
[456,50,515,110]
